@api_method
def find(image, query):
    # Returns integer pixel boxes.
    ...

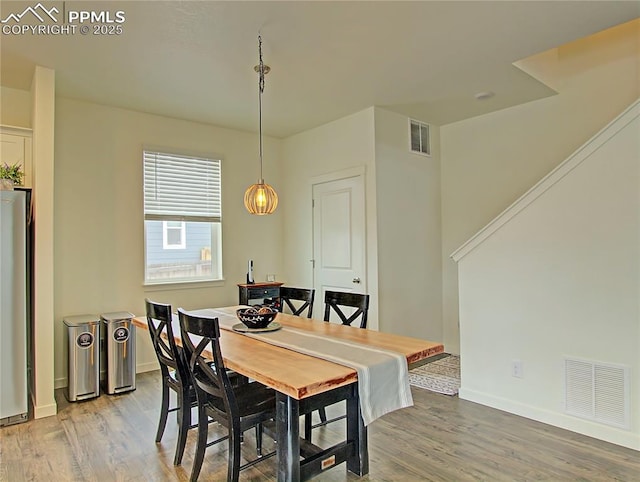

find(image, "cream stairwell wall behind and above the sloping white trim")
[440,26,640,352]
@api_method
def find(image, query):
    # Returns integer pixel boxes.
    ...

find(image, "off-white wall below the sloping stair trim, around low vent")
[456,103,640,450]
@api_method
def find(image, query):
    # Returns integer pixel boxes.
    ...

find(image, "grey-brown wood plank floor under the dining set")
[0,372,640,482]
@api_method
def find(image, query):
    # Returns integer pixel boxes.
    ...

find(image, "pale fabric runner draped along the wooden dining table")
[190,309,413,425]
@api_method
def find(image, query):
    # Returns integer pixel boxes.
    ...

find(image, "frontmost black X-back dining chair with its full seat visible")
[178,309,276,482]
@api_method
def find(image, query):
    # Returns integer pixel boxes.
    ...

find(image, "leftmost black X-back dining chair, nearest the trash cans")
[145,299,197,465]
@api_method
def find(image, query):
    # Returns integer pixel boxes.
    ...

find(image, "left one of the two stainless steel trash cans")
[62,315,100,402]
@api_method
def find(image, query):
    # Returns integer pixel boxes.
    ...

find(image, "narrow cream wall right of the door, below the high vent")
[375,108,442,341]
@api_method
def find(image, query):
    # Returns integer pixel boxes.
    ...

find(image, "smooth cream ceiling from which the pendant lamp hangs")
[0,0,640,137]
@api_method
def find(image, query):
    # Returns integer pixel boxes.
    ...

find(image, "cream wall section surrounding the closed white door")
[278,108,378,329]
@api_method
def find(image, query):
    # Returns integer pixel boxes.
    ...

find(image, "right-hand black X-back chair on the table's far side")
[304,290,369,441]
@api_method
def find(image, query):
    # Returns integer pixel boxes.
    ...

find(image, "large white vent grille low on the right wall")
[565,358,630,428]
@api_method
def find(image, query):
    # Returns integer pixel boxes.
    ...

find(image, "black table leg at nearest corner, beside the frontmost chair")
[276,392,300,482]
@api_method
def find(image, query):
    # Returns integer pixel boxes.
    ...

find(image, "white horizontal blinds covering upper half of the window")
[144,151,222,222]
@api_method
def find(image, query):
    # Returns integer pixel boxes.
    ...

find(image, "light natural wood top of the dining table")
[133,306,444,400]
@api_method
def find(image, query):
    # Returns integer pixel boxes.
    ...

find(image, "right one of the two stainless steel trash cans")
[100,311,136,395]
